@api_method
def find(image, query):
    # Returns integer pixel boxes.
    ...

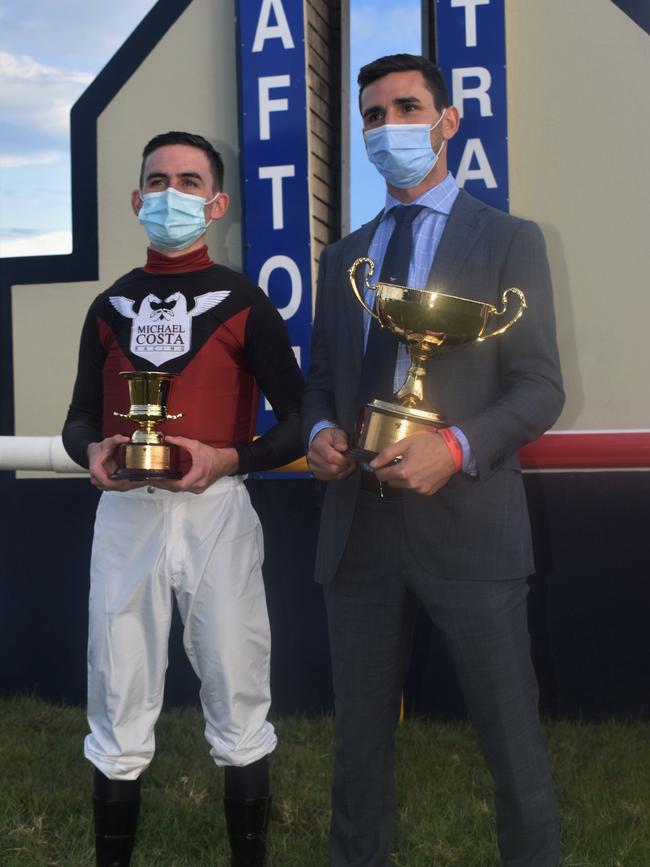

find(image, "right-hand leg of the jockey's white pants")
[172,479,277,766]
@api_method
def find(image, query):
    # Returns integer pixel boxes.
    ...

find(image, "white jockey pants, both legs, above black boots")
[84,477,277,780]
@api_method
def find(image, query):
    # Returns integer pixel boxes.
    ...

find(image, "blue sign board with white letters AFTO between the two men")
[237,0,312,433]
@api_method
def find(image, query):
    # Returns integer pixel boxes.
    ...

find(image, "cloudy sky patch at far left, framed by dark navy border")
[0,0,155,256]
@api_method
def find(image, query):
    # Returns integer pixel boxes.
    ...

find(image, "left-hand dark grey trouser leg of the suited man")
[325,497,414,867]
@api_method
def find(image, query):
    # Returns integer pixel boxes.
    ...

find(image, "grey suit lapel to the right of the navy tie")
[427,190,486,294]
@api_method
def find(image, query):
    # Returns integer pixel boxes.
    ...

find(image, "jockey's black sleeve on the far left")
[62,306,106,468]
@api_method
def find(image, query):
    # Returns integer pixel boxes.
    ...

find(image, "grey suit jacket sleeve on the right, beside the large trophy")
[460,222,564,479]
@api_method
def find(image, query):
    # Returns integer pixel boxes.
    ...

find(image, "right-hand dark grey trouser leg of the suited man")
[420,579,559,867]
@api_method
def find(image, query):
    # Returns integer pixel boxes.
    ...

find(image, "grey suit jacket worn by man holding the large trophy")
[303,190,564,583]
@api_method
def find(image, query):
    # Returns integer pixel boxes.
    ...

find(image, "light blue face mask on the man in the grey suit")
[364,109,447,189]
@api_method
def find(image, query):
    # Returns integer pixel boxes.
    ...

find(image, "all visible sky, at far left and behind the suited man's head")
[0,0,421,257]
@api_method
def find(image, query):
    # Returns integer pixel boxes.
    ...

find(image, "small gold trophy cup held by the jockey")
[111,370,183,481]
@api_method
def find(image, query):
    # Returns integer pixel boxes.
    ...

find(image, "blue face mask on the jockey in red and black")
[138,187,220,250]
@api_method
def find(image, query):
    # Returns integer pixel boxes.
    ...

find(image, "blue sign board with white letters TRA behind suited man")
[435,0,508,211]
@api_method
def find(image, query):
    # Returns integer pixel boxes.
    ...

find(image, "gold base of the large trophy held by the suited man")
[347,400,448,464]
